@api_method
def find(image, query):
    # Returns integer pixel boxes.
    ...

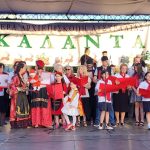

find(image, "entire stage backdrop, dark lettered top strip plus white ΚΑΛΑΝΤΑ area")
[0,23,150,66]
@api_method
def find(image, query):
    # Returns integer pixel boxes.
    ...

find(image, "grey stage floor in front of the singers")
[0,122,150,150]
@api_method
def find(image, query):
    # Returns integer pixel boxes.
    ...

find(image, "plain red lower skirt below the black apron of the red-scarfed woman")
[31,101,52,127]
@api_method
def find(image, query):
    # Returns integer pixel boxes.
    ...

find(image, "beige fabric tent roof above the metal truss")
[0,0,150,15]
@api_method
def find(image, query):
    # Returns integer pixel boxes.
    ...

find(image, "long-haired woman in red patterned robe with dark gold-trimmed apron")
[9,62,31,128]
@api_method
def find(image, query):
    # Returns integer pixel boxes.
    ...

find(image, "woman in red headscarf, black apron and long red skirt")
[31,60,52,128]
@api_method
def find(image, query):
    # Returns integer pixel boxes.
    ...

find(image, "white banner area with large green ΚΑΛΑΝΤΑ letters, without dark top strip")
[0,24,150,66]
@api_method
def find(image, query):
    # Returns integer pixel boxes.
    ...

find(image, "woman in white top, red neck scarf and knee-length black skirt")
[113,64,129,126]
